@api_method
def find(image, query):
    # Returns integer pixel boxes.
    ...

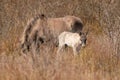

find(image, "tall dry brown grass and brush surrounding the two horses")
[0,0,120,80]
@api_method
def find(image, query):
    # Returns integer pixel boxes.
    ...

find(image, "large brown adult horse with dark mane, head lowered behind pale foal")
[21,14,83,52]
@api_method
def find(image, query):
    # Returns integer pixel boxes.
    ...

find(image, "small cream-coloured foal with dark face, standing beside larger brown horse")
[57,31,87,55]
